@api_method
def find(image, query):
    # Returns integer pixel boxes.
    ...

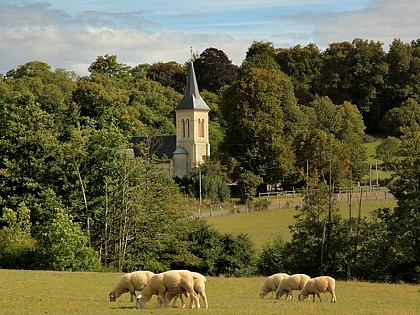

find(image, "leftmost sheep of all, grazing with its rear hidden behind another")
[109,271,154,302]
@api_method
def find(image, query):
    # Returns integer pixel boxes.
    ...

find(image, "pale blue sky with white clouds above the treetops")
[0,0,420,75]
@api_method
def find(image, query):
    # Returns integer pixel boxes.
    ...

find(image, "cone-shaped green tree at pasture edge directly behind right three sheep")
[282,184,346,277]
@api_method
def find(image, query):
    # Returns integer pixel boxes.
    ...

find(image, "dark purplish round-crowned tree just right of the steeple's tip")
[194,48,238,93]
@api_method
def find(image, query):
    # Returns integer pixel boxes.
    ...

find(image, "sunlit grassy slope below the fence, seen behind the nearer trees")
[205,198,396,251]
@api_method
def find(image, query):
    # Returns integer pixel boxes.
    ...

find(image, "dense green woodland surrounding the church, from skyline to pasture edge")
[0,39,420,282]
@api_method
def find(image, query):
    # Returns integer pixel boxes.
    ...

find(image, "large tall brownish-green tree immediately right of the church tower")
[220,68,295,183]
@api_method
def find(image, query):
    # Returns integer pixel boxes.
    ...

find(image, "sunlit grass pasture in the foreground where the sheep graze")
[0,270,420,315]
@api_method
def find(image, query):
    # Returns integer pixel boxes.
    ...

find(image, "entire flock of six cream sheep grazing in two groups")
[109,270,337,309]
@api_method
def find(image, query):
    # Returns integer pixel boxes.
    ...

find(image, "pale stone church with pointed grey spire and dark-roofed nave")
[132,62,210,178]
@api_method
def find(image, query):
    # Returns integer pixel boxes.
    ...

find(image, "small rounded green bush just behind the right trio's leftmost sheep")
[257,237,285,276]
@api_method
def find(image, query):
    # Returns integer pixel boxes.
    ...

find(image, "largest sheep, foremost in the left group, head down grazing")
[136,270,200,308]
